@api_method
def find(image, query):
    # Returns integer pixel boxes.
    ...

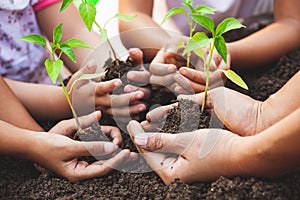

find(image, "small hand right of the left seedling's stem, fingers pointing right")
[67,61,146,122]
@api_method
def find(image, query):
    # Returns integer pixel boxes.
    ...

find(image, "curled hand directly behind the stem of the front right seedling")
[174,50,230,94]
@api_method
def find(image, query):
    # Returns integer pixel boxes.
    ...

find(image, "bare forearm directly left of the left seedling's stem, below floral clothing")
[6,79,72,120]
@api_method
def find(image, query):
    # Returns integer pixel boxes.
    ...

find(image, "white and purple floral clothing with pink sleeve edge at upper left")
[0,0,58,83]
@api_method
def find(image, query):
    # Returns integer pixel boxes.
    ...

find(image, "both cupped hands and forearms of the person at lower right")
[127,72,300,185]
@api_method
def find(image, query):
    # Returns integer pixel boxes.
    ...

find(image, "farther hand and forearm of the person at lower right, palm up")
[142,72,300,136]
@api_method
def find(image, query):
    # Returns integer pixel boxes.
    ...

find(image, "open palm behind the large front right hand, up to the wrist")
[178,87,267,136]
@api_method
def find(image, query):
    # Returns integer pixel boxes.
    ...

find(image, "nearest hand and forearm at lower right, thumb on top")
[128,108,300,185]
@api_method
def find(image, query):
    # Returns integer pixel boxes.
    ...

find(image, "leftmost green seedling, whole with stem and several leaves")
[20,24,103,134]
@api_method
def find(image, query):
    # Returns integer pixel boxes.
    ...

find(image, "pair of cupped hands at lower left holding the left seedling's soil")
[29,112,134,182]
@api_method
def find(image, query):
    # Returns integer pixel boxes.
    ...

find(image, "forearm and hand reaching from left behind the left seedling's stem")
[5,49,149,120]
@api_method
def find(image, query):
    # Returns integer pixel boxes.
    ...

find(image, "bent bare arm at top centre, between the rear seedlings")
[119,0,170,61]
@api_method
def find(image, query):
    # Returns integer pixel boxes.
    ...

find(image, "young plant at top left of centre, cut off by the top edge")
[60,0,136,65]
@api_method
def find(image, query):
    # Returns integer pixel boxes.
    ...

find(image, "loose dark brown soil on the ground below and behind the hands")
[0,14,300,199]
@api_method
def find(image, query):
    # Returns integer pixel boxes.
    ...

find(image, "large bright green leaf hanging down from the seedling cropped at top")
[79,3,97,31]
